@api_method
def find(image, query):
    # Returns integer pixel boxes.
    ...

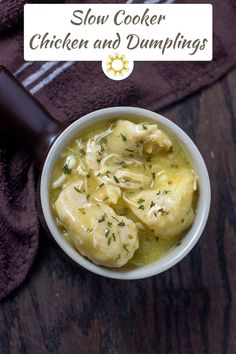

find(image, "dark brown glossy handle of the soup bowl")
[0,66,66,163]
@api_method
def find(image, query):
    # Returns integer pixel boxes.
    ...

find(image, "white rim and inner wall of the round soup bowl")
[40,107,211,280]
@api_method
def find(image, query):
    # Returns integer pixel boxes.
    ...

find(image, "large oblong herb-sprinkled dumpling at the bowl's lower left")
[55,185,139,267]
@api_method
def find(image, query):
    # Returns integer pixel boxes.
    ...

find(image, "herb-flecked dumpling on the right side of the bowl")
[124,169,196,238]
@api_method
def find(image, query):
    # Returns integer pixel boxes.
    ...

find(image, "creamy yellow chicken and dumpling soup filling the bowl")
[50,118,197,269]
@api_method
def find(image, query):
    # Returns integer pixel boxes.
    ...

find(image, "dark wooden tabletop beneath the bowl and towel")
[0,70,236,354]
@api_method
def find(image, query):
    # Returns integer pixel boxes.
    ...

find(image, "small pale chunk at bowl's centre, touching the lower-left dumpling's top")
[93,184,121,204]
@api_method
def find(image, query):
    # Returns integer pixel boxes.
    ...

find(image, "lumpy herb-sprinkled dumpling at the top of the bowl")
[107,120,172,156]
